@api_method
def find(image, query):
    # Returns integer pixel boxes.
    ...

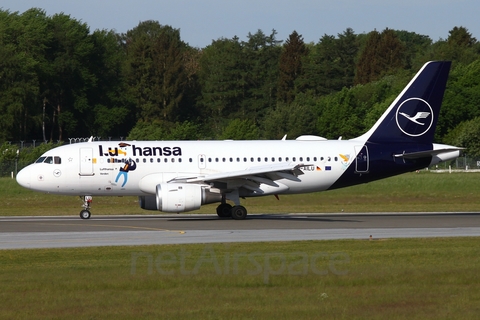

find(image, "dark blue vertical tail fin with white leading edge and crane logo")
[358,61,451,143]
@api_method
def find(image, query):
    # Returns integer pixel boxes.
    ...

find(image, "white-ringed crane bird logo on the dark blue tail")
[395,98,434,137]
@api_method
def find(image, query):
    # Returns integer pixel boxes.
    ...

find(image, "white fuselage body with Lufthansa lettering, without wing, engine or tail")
[17,140,362,196]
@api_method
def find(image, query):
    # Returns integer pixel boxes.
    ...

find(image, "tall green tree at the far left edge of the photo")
[0,9,51,141]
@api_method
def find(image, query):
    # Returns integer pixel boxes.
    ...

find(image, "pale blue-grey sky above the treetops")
[0,0,480,48]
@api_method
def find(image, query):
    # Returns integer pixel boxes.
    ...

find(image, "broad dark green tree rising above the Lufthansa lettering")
[123,21,187,122]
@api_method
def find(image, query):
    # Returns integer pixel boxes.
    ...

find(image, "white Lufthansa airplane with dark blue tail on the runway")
[16,61,463,220]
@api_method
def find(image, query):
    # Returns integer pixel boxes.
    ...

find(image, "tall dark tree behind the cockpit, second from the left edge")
[42,14,97,141]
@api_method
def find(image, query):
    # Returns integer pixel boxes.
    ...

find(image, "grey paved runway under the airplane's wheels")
[0,213,480,249]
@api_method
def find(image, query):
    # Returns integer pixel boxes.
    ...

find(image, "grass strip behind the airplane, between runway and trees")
[0,172,480,216]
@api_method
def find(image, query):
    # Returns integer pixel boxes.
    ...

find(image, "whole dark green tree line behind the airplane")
[0,8,480,155]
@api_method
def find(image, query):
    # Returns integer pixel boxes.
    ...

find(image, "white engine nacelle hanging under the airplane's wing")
[138,183,222,212]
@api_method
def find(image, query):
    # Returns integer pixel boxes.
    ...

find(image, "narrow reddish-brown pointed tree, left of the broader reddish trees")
[277,31,308,104]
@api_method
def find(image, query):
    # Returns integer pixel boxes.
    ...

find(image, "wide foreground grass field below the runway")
[0,238,480,319]
